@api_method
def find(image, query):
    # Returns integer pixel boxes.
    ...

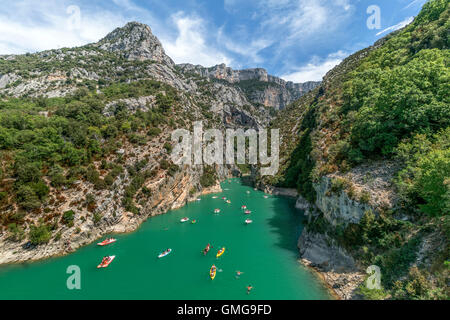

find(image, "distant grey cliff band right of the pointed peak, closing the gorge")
[178,64,320,110]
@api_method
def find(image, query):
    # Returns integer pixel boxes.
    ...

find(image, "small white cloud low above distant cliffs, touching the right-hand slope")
[281,51,348,83]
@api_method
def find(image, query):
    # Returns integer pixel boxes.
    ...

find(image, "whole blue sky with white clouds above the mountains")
[0,0,426,82]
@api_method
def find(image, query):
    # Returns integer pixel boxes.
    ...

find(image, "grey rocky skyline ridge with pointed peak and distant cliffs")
[0,22,319,110]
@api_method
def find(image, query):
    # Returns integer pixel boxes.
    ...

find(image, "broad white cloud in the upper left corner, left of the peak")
[0,0,126,54]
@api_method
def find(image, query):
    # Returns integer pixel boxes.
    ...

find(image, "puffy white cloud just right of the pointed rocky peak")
[161,12,232,66]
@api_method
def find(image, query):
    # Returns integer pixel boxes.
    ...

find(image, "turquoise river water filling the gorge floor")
[0,179,331,300]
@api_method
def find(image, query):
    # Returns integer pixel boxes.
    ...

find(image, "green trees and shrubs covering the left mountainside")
[0,80,183,234]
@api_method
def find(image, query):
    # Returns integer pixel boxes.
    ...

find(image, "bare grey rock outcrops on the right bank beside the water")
[296,162,397,299]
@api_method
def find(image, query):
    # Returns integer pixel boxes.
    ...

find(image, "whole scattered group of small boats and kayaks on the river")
[93,191,268,280]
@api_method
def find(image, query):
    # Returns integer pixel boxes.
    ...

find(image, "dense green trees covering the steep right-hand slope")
[270,0,450,215]
